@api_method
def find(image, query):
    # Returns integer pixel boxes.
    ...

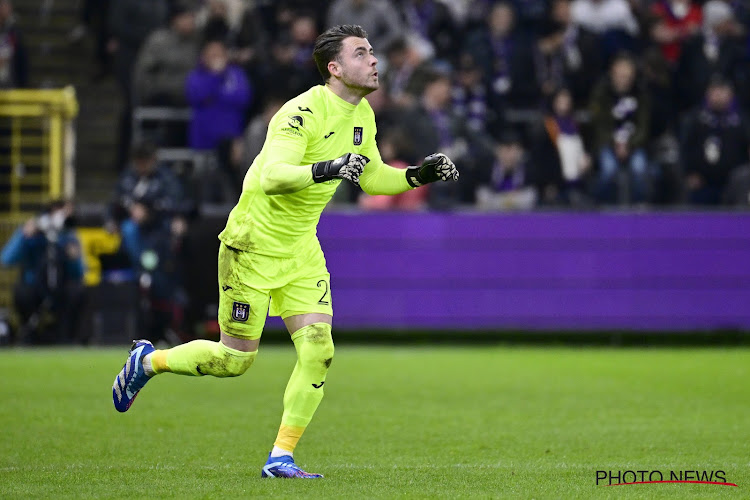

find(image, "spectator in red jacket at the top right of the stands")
[650,0,703,67]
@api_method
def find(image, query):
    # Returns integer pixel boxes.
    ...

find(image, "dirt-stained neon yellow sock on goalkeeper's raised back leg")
[144,340,258,377]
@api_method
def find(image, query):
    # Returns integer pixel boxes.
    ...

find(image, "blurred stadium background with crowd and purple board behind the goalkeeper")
[0,0,750,345]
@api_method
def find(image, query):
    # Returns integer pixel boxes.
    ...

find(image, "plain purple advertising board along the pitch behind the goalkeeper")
[318,212,750,331]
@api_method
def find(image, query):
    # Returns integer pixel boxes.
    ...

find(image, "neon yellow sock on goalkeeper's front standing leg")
[274,323,334,452]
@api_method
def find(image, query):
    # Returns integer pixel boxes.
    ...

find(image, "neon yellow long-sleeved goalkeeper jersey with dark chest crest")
[219,85,388,257]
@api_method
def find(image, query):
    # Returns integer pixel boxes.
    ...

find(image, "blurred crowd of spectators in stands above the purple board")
[97,0,750,209]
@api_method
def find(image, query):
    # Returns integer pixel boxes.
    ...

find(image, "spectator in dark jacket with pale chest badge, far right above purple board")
[682,76,750,205]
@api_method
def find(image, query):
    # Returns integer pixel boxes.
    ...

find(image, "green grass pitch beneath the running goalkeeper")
[0,345,750,499]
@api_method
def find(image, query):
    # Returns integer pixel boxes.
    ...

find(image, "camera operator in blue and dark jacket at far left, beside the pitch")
[0,201,84,343]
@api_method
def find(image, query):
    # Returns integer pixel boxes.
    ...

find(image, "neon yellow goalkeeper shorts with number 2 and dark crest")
[219,243,333,339]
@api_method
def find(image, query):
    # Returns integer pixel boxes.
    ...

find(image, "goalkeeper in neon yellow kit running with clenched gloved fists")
[112,25,458,478]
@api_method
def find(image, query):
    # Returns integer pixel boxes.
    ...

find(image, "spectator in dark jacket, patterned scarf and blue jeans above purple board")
[590,55,650,203]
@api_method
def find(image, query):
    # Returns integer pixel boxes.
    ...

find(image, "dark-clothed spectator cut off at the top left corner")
[0,0,29,89]
